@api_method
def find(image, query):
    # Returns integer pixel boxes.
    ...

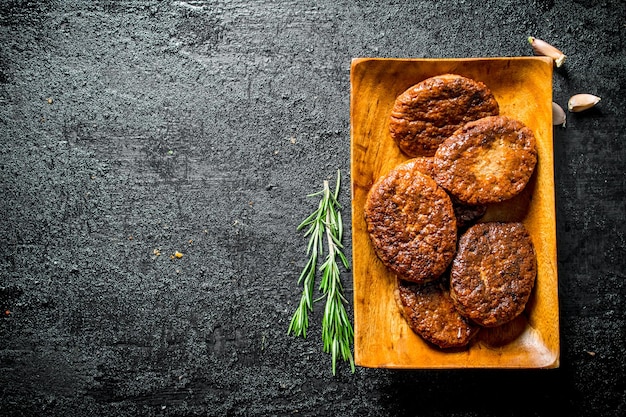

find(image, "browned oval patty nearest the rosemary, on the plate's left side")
[365,161,457,283]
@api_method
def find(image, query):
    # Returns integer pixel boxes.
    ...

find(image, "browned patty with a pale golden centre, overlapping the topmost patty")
[435,116,537,204]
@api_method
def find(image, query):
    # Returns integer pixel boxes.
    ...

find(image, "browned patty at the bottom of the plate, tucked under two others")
[396,279,480,349]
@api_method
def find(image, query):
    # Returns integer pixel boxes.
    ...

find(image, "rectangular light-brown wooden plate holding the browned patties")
[350,57,559,369]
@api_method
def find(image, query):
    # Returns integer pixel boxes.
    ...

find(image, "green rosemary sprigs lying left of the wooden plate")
[287,171,354,375]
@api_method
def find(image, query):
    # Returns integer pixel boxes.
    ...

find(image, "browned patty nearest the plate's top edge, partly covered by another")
[389,74,499,157]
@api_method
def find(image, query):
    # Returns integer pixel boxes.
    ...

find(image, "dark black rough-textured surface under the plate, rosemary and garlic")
[0,0,626,416]
